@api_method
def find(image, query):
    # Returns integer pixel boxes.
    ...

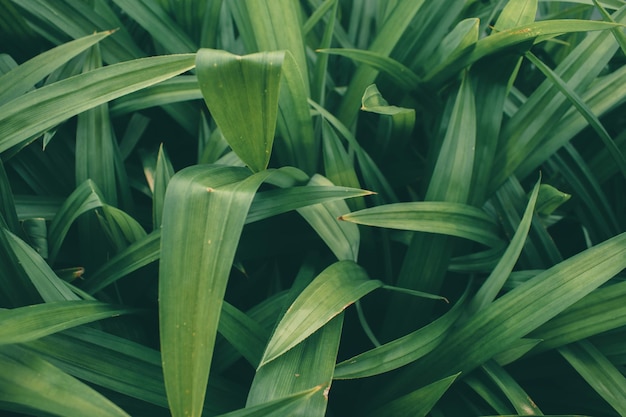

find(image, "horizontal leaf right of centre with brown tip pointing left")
[340,201,503,247]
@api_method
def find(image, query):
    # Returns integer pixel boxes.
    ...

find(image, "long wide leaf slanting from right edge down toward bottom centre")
[376,234,626,395]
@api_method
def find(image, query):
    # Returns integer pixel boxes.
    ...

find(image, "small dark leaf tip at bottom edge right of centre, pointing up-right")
[367,373,460,417]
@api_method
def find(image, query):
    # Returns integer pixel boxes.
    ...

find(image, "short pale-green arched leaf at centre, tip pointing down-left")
[261,261,382,366]
